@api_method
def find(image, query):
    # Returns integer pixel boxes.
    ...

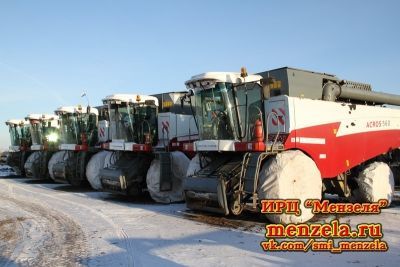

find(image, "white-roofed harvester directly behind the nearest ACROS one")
[100,92,197,202]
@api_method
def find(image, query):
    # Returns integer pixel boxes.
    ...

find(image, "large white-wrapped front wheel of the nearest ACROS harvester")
[258,150,322,224]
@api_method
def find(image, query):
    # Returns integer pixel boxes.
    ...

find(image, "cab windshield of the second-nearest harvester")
[109,102,157,144]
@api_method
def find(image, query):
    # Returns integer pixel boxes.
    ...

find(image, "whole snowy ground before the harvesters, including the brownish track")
[0,178,400,266]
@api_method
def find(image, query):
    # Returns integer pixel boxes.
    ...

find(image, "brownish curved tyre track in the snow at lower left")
[0,196,86,266]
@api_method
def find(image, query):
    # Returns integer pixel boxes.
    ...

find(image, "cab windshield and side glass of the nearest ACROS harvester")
[195,83,262,140]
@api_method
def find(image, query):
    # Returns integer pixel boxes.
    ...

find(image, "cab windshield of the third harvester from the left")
[60,113,97,146]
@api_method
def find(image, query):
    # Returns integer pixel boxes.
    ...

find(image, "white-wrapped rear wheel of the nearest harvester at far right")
[353,162,394,205]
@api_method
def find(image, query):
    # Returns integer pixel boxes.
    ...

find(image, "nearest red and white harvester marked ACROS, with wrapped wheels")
[184,68,400,223]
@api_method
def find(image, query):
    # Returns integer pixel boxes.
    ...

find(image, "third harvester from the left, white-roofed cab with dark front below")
[48,106,99,186]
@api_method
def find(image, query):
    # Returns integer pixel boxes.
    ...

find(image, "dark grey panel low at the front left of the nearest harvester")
[184,177,229,215]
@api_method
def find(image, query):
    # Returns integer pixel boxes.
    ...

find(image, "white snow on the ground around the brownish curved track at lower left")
[0,179,400,267]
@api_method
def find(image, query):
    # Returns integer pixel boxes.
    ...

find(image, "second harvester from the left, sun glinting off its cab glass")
[24,114,60,179]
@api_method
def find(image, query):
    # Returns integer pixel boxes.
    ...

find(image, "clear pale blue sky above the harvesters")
[0,0,400,149]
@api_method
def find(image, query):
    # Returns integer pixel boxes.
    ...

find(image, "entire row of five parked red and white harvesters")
[6,67,400,223]
